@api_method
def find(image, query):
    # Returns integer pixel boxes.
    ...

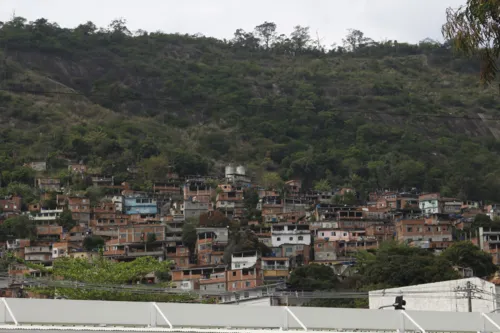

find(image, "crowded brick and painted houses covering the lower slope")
[0,163,500,297]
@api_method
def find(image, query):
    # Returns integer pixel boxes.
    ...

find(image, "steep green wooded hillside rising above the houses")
[0,18,500,201]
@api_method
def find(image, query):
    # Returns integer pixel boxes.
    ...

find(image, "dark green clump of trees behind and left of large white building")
[289,241,497,307]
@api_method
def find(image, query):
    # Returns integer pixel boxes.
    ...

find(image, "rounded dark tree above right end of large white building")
[441,242,497,278]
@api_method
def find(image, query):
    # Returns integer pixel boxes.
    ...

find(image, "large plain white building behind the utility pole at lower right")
[369,278,497,313]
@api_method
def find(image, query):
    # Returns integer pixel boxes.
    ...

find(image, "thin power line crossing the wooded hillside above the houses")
[0,88,500,121]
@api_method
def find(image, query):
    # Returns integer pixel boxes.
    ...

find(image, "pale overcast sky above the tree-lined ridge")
[0,0,466,45]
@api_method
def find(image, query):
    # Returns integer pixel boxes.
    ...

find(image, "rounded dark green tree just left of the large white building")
[288,264,339,290]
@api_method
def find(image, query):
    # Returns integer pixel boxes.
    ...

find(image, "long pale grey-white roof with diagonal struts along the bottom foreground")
[0,298,500,333]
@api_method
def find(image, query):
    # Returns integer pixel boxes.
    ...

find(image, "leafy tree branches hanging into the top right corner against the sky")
[442,0,500,83]
